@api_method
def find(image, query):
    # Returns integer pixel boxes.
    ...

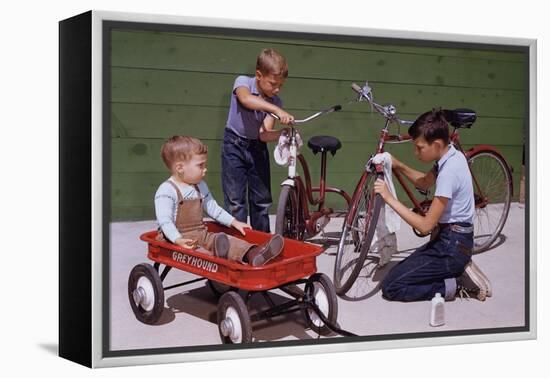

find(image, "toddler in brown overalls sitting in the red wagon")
[155,136,284,266]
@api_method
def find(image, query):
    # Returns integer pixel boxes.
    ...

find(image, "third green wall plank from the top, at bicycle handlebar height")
[111,103,525,145]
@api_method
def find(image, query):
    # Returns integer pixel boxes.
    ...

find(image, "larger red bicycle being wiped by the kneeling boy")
[333,83,513,295]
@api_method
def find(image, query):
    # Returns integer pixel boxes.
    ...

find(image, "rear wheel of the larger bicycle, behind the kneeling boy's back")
[468,150,512,253]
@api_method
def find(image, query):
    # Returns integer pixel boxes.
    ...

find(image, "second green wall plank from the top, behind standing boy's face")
[111,68,525,118]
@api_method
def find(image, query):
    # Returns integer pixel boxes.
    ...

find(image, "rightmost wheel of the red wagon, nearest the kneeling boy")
[304,273,338,335]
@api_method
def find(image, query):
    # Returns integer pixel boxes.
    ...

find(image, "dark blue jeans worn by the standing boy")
[222,129,272,232]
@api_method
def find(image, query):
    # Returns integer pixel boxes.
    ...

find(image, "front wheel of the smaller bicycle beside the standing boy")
[275,186,305,240]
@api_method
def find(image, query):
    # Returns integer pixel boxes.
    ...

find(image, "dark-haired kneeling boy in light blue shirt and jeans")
[375,110,490,301]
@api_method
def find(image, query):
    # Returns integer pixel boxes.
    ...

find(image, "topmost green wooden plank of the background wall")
[111,32,525,90]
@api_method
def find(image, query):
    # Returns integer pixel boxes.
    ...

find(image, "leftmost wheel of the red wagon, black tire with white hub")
[128,264,164,324]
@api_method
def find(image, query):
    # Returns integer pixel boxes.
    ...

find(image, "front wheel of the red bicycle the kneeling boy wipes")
[334,172,382,295]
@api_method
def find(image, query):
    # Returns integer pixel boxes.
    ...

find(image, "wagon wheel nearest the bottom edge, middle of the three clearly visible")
[218,291,252,344]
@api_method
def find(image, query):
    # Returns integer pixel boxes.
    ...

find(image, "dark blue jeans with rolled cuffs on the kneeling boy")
[382,227,474,302]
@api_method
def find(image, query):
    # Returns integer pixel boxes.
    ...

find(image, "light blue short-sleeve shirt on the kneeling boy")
[434,145,475,223]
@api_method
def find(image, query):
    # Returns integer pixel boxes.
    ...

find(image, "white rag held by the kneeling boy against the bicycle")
[371,152,401,266]
